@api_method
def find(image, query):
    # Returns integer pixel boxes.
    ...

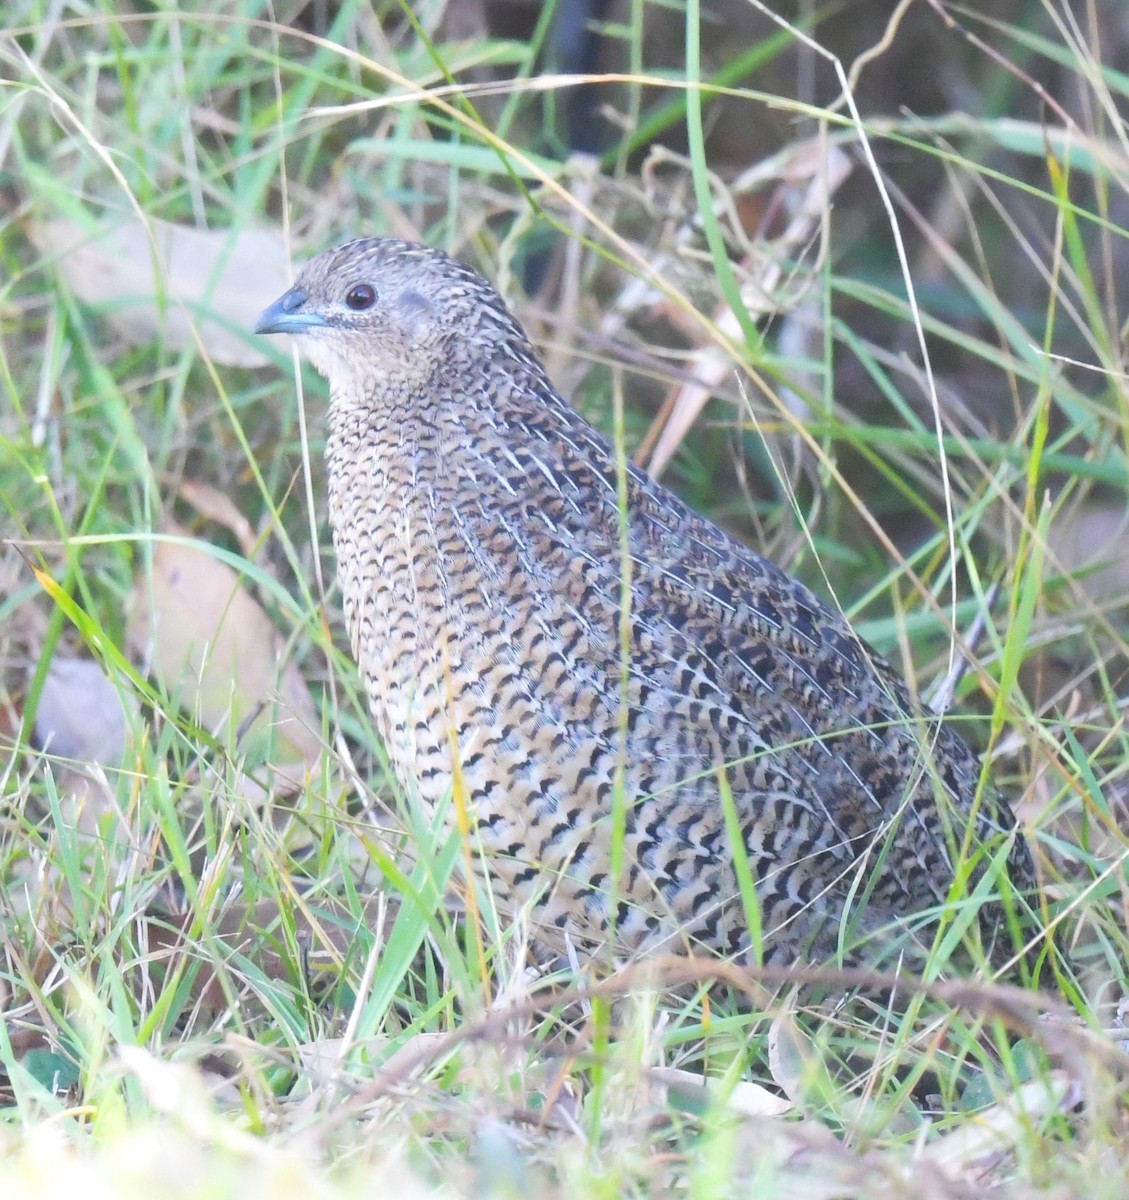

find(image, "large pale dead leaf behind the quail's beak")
[31,217,290,367]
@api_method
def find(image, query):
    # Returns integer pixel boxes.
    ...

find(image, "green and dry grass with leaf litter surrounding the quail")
[0,0,1129,1200]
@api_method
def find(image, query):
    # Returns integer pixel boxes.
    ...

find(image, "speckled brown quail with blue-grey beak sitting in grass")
[256,239,1034,962]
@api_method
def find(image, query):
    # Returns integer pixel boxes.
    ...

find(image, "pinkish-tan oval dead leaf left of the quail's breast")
[128,530,322,790]
